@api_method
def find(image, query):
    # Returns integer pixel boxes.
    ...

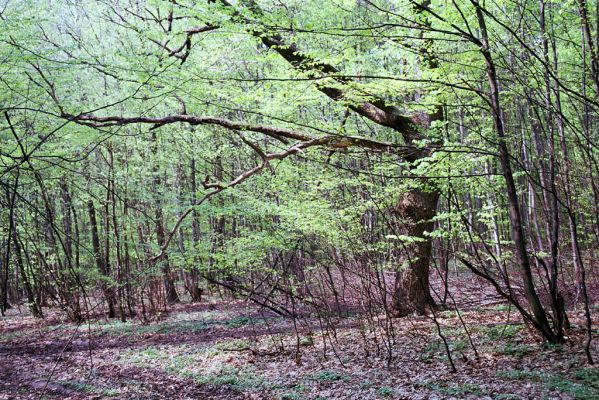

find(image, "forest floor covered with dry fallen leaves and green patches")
[0,280,599,400]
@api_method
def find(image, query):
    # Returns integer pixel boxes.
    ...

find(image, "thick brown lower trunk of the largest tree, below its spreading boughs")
[393,189,439,317]
